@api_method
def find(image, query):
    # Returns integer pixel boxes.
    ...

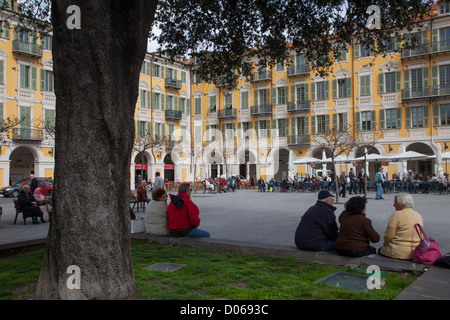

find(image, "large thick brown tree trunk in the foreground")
[36,0,157,299]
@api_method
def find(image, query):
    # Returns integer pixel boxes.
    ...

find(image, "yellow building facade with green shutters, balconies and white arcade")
[0,1,450,189]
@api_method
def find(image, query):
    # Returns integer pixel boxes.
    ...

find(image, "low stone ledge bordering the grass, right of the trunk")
[131,233,428,272]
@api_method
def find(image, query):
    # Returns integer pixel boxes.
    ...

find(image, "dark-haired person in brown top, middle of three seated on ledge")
[336,196,380,257]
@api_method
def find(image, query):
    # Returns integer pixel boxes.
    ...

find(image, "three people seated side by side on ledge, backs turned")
[294,190,423,259]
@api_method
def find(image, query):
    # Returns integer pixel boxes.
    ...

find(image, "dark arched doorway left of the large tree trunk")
[9,147,36,184]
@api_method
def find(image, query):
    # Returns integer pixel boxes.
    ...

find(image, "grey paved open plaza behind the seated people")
[0,190,450,254]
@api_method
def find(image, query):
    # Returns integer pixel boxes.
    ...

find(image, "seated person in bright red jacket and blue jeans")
[168,183,210,238]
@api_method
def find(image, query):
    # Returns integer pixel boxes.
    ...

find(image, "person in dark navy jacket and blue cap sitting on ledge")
[295,189,338,251]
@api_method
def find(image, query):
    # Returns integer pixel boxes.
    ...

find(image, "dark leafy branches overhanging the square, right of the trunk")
[155,0,434,83]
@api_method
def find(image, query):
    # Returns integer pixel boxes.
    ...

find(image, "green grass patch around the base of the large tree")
[0,240,418,300]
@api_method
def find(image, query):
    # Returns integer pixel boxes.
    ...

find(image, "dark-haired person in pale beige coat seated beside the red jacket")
[145,189,169,236]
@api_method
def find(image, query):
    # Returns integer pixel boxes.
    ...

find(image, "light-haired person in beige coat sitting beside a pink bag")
[379,193,423,259]
